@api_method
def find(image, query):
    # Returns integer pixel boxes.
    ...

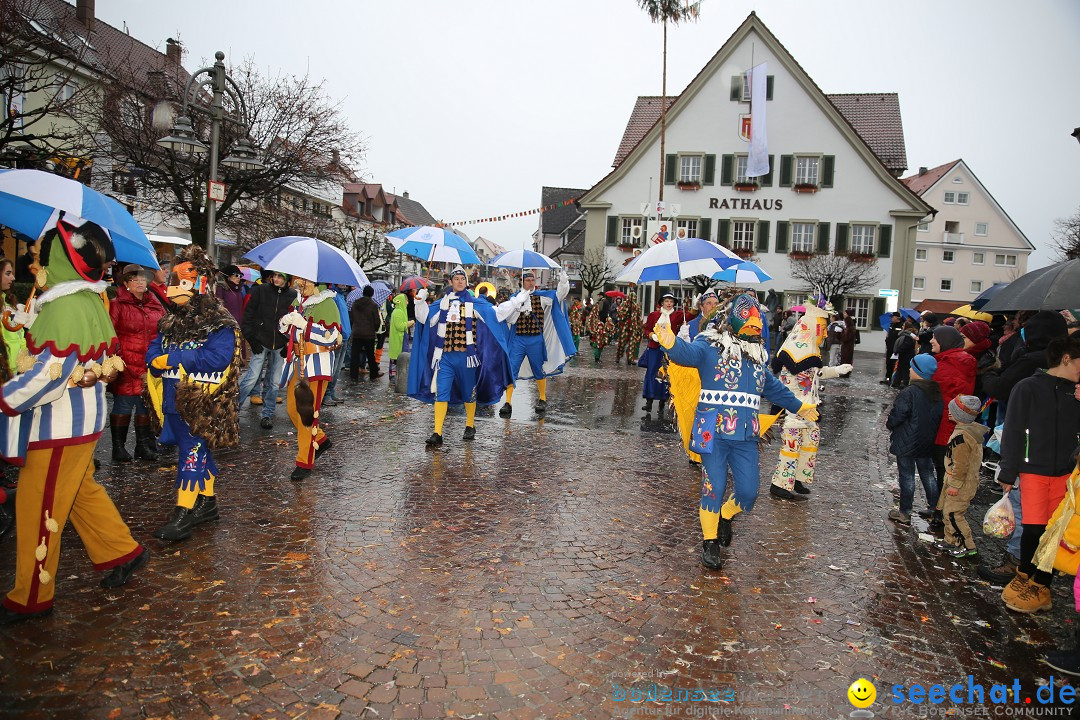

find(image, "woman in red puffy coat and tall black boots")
[109,264,165,462]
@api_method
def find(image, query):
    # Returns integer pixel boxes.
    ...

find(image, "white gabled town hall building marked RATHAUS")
[579,13,931,338]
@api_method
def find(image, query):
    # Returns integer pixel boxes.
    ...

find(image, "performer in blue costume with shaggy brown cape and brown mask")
[144,245,242,541]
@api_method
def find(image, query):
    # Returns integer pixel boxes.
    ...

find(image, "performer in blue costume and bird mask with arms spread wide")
[656,295,818,570]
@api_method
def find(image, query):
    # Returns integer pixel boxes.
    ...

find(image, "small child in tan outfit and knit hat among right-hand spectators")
[934,395,989,558]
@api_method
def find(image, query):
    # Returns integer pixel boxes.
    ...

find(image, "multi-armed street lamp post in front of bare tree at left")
[158,51,265,263]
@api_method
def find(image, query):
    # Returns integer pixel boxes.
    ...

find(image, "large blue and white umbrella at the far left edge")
[0,169,159,268]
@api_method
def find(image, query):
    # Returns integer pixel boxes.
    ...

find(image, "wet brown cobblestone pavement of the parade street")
[0,354,1076,719]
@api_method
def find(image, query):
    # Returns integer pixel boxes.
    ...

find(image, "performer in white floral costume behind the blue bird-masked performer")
[769,301,851,501]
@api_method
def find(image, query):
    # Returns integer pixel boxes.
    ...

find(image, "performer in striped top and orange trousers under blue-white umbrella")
[278,277,341,480]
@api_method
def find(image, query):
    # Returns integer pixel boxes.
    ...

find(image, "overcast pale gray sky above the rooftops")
[99,0,1080,268]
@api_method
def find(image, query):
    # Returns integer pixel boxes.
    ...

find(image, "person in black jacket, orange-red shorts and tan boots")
[998,334,1080,613]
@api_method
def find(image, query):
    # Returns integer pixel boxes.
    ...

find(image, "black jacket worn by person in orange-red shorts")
[998,371,1080,485]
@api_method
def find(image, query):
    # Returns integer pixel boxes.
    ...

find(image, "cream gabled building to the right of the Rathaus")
[903,160,1035,312]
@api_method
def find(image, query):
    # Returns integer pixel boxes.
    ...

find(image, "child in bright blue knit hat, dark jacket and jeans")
[886,355,943,525]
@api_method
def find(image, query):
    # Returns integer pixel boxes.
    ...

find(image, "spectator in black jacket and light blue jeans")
[237,272,296,430]
